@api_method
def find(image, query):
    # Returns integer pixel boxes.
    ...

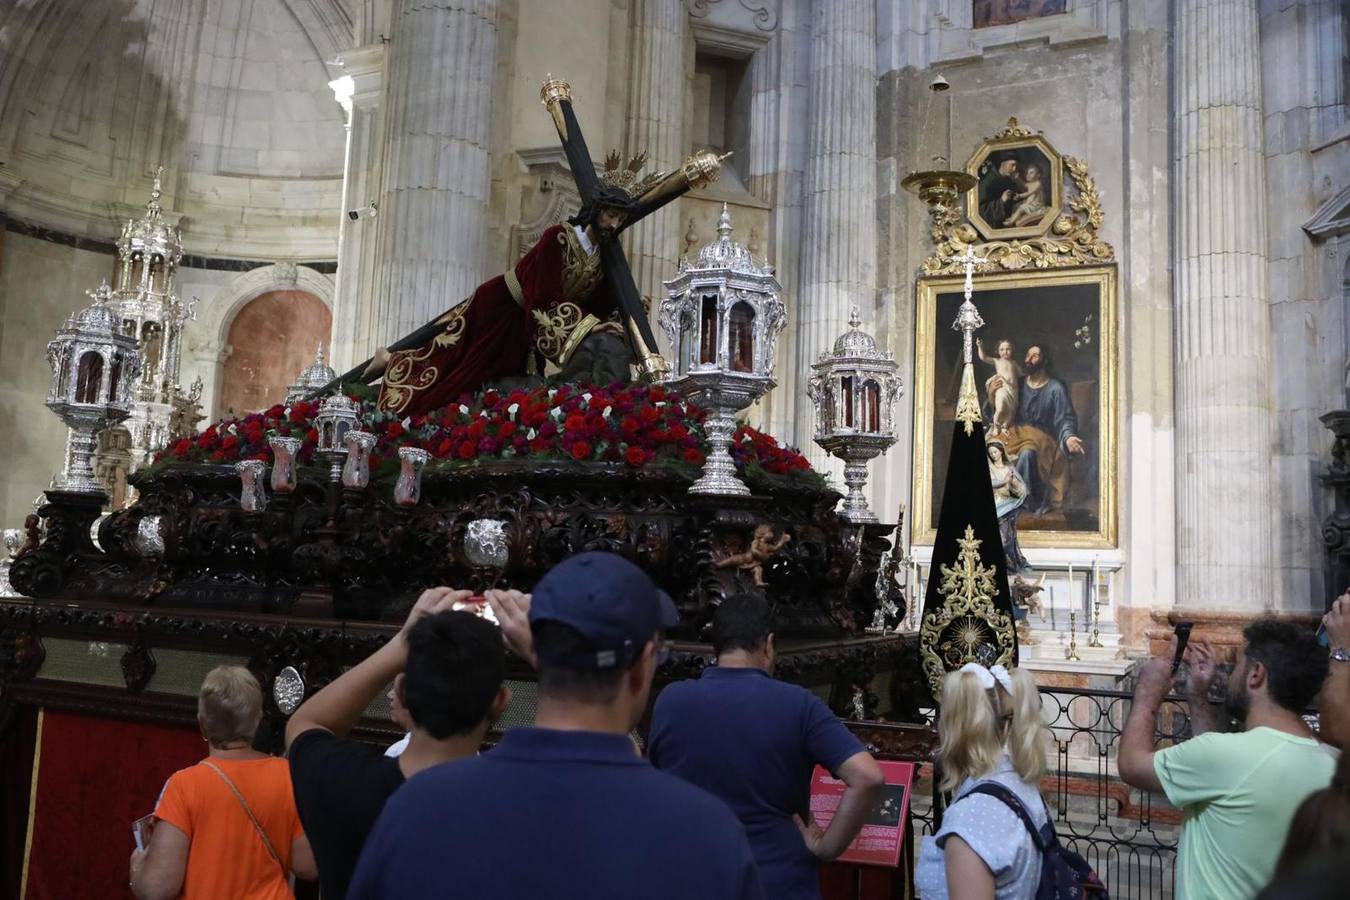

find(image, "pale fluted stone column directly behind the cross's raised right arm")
[621,0,689,322]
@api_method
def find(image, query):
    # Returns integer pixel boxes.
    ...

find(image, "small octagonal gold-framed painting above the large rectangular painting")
[965,135,1064,240]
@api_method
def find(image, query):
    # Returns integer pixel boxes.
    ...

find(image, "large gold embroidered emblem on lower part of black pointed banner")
[919,525,1014,698]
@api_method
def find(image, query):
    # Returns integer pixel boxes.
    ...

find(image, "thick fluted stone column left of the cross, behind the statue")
[371,0,500,344]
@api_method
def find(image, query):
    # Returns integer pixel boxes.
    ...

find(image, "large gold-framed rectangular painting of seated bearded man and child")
[914,266,1116,546]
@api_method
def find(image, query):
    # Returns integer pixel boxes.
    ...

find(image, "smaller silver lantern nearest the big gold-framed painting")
[807,309,900,522]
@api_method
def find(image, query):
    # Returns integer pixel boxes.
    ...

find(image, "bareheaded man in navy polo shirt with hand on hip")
[648,594,884,900]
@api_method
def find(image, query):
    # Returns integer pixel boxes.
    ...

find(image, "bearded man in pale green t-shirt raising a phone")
[1118,619,1337,900]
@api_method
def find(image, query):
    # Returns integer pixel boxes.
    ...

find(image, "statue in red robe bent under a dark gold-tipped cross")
[324,78,721,416]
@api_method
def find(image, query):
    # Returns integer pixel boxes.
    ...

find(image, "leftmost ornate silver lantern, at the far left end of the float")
[47,281,142,494]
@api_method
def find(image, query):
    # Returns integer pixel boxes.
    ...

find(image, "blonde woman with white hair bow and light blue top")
[914,663,1049,900]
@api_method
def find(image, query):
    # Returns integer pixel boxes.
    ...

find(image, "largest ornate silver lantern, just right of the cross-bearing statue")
[659,204,784,495]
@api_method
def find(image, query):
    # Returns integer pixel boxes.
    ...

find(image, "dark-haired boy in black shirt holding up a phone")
[286,587,510,900]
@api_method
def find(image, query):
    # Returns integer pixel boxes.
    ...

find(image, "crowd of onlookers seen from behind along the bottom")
[131,553,1350,900]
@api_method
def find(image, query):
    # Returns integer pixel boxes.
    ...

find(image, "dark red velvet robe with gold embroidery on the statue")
[379,225,616,416]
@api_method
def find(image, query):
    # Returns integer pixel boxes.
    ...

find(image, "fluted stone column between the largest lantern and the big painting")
[784,0,876,471]
